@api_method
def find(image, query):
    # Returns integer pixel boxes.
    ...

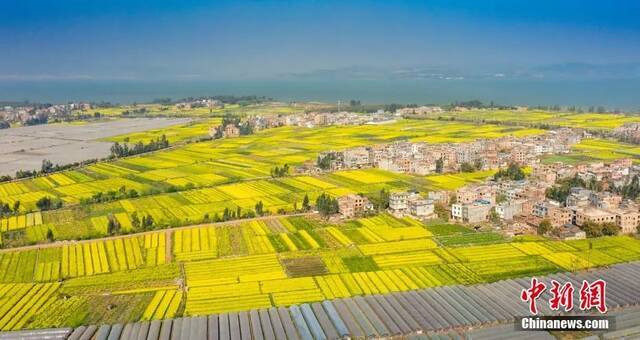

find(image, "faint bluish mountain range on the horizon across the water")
[281,63,640,80]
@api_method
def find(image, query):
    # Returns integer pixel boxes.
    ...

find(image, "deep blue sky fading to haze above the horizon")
[0,0,640,80]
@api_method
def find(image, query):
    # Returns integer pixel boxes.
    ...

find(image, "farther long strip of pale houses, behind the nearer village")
[308,129,583,175]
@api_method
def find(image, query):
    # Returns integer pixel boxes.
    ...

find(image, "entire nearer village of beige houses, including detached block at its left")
[338,159,640,239]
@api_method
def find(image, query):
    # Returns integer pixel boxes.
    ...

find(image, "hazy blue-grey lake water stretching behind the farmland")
[0,79,640,111]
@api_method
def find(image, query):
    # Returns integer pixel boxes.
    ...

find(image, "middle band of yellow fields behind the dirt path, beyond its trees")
[0,120,542,244]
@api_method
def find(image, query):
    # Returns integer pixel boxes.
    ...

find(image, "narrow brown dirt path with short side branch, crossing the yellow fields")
[0,212,317,252]
